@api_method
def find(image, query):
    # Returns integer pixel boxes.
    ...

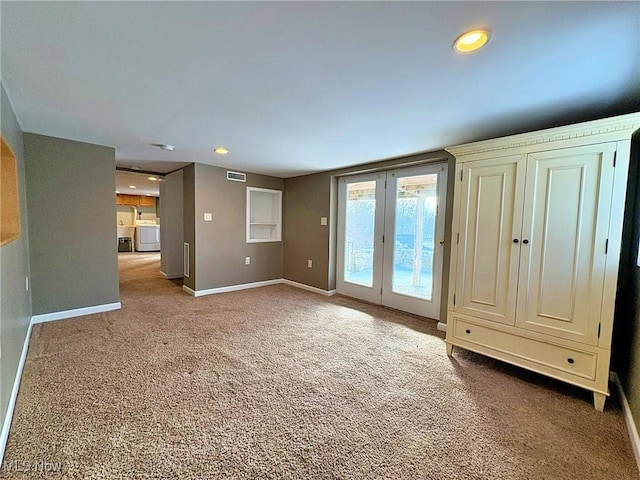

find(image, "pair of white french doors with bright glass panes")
[336,164,447,319]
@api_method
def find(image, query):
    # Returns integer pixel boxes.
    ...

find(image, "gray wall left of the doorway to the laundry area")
[24,133,119,315]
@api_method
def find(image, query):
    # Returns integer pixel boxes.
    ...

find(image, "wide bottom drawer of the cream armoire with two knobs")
[453,318,598,380]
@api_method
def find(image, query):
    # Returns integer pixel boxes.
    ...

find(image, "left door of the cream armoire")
[455,155,525,325]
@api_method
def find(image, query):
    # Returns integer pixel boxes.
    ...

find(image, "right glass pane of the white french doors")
[391,173,438,301]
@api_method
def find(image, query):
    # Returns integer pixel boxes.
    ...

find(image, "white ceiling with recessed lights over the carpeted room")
[0,1,640,177]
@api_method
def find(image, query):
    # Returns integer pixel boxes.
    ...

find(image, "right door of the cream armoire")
[517,144,616,345]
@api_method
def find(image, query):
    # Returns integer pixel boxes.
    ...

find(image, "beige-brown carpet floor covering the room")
[0,254,639,480]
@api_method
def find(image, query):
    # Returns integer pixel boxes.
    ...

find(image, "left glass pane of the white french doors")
[344,181,376,287]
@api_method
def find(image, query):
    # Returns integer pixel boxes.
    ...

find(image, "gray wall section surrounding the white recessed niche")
[184,164,284,290]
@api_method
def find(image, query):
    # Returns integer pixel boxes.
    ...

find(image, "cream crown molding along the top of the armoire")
[445,112,640,159]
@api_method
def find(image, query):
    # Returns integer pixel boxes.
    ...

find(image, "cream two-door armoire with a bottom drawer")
[446,114,640,411]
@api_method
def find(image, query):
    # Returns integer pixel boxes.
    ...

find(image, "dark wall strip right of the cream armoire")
[613,131,640,430]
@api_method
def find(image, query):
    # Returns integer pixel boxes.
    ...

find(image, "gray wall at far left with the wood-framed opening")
[0,84,31,436]
